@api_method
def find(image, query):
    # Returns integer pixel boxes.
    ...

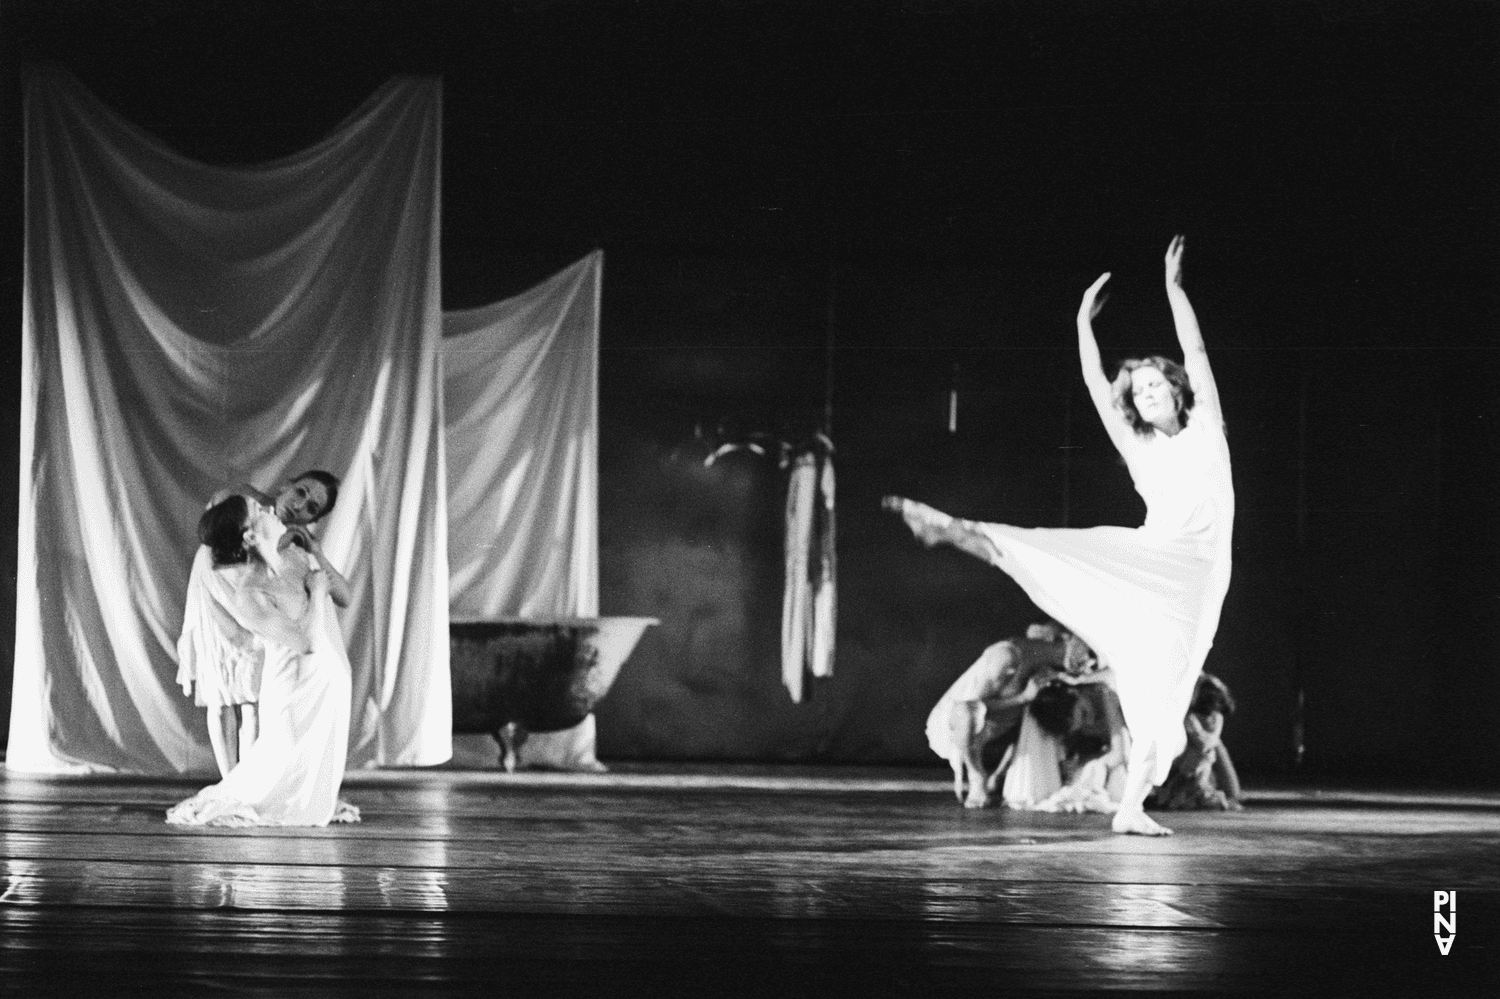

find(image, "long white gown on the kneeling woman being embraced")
[167,549,359,825]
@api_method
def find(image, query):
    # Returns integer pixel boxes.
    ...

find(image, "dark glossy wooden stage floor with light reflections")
[0,768,1500,998]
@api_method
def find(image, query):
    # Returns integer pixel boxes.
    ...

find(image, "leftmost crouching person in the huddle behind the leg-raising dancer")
[927,624,1094,809]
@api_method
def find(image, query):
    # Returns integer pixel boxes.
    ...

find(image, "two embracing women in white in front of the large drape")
[167,471,359,825]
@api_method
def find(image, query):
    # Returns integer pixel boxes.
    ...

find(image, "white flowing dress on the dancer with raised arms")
[974,419,1235,785]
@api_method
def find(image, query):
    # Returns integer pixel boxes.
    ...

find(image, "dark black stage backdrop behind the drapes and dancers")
[0,0,1500,785]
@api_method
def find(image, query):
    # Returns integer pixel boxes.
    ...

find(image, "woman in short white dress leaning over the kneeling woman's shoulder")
[177,470,350,777]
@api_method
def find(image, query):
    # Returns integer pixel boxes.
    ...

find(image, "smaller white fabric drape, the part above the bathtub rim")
[443,252,603,618]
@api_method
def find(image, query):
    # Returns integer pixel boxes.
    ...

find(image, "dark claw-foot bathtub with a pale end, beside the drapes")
[449,617,659,770]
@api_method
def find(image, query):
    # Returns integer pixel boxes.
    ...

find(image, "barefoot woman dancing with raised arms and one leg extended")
[884,236,1235,836]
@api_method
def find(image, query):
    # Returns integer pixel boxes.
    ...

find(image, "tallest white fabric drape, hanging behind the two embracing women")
[8,71,452,773]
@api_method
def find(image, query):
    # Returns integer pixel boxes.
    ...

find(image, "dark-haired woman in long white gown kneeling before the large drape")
[167,495,359,825]
